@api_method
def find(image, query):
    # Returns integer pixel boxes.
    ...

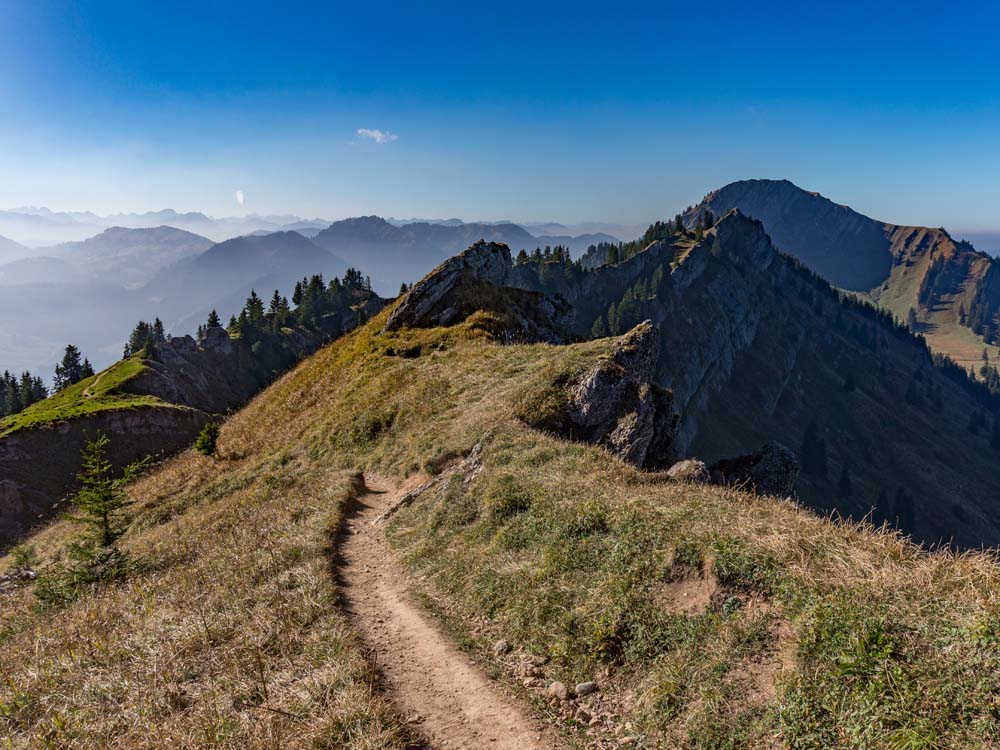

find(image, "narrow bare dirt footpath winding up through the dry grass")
[338,476,563,750]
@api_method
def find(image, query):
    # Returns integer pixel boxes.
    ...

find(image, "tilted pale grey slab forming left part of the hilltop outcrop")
[385,240,512,331]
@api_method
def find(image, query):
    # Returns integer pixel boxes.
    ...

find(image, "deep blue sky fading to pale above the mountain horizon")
[0,0,1000,230]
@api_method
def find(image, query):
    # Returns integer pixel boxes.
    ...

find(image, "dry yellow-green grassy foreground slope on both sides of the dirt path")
[0,316,1000,748]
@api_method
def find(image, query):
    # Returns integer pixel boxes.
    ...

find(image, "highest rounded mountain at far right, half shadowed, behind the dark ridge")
[684,180,1000,370]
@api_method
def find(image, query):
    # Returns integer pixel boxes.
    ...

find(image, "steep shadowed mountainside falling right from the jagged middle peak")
[512,208,1000,546]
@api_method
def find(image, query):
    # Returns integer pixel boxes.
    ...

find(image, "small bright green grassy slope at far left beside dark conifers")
[0,357,169,437]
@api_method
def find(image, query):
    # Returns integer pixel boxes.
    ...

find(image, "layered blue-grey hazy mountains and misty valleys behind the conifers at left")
[0,208,617,377]
